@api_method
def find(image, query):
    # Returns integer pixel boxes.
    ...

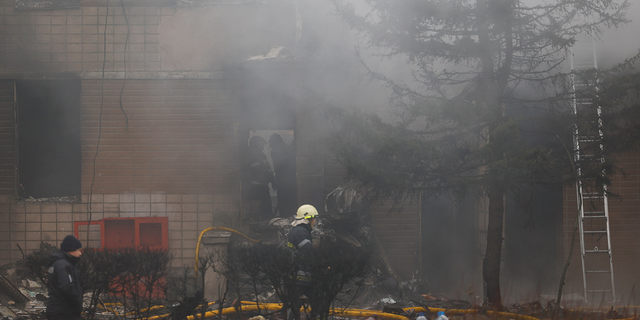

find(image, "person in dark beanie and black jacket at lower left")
[47,235,83,320]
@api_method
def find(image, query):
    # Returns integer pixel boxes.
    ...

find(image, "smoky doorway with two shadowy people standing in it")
[240,82,298,225]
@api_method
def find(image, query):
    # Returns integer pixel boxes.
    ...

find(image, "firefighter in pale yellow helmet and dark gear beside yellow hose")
[287,204,318,297]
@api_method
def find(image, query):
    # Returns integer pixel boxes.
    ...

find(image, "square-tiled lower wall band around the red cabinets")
[0,194,237,268]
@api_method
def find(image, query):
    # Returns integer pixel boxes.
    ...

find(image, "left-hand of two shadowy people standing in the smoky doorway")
[242,136,275,220]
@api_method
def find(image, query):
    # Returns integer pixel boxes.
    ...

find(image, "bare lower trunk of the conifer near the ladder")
[482,183,504,310]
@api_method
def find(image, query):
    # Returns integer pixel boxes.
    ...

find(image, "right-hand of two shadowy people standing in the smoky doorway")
[269,133,298,217]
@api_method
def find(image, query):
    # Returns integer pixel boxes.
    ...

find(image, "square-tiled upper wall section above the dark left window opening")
[0,0,163,72]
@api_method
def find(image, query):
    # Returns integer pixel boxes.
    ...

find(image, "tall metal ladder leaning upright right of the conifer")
[570,37,616,303]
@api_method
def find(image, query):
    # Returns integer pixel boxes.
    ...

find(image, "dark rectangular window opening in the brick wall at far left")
[15,79,81,199]
